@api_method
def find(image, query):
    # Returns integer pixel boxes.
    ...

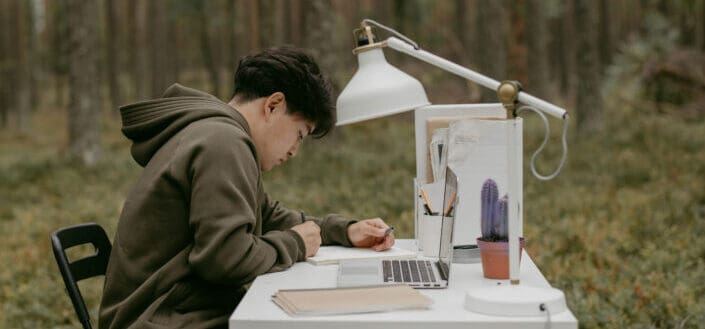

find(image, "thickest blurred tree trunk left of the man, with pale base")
[64,0,101,166]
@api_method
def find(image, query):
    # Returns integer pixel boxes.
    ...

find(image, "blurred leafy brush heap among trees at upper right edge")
[603,13,705,119]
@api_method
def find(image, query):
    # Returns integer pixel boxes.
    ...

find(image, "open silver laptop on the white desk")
[338,167,460,289]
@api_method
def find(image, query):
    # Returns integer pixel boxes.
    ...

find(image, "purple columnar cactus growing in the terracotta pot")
[480,178,508,241]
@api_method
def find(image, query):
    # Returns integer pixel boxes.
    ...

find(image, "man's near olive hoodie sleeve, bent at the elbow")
[172,124,305,284]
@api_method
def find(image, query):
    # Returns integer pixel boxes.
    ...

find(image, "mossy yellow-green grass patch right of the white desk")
[525,114,705,328]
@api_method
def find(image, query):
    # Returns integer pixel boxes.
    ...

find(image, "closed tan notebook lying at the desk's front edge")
[272,285,433,316]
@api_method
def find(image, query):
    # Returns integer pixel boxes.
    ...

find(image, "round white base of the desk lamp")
[465,284,568,316]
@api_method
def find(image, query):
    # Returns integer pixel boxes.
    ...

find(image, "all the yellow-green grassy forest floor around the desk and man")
[0,91,705,328]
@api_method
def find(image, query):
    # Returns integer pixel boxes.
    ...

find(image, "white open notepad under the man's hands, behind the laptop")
[306,246,416,265]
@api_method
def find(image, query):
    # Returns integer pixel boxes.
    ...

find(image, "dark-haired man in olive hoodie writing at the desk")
[99,48,394,329]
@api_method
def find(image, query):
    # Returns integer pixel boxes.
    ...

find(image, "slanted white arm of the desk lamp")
[386,37,567,119]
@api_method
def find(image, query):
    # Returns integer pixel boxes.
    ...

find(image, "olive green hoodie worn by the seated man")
[99,85,352,329]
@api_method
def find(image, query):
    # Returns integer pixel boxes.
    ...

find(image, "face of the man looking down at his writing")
[258,103,315,171]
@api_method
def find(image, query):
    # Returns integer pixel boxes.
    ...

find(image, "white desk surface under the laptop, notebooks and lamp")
[229,240,578,329]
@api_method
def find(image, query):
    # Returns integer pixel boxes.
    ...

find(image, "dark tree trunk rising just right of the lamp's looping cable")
[575,0,602,133]
